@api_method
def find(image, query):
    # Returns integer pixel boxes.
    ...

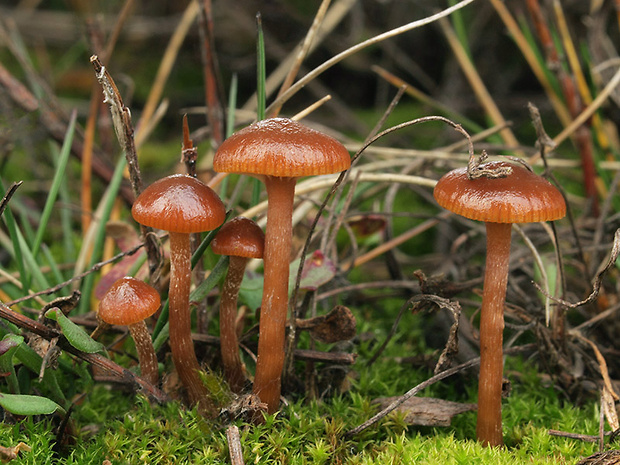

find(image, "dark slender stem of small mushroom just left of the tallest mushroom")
[220,256,248,394]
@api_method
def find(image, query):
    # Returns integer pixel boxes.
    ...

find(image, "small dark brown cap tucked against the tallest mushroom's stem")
[211,216,265,258]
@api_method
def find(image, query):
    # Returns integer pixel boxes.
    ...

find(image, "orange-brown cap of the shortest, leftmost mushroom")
[99,277,161,326]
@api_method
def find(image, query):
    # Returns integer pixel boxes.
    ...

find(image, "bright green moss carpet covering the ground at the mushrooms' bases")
[0,325,598,465]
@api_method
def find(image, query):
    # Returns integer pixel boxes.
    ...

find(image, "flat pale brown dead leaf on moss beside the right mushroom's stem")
[373,396,478,426]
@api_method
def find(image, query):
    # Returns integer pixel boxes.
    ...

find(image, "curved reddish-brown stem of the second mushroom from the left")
[168,232,215,414]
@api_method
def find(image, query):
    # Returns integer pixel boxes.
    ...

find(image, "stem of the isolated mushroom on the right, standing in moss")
[476,223,512,446]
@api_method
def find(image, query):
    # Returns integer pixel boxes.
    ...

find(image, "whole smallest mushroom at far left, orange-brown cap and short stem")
[98,276,161,385]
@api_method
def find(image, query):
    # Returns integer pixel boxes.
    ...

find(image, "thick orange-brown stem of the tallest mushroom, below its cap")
[253,176,296,414]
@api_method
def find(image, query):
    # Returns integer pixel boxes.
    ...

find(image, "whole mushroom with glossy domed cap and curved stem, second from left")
[131,174,226,415]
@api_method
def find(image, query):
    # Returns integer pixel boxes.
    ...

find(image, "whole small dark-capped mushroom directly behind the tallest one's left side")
[211,216,265,393]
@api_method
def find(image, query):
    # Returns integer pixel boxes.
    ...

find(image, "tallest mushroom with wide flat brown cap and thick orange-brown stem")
[213,118,351,413]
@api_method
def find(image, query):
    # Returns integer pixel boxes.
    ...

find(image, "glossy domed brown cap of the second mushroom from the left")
[131,174,226,234]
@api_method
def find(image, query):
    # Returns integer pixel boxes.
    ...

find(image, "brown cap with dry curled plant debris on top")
[434,162,566,223]
